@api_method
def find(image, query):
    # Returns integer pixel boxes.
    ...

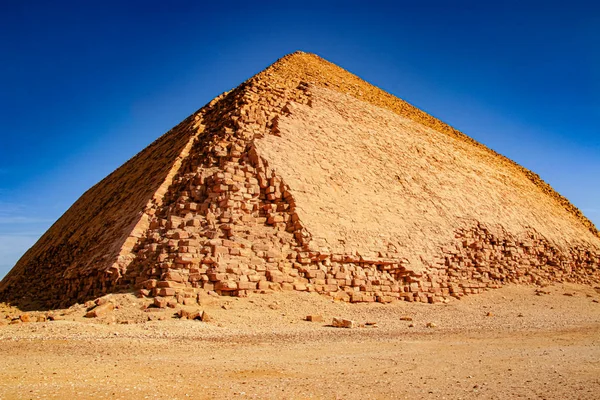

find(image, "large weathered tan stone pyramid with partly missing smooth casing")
[0,52,600,307]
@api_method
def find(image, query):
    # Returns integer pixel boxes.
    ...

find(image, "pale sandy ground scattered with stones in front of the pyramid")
[0,285,600,399]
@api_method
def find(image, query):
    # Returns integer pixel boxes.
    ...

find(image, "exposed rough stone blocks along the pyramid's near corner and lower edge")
[67,91,600,310]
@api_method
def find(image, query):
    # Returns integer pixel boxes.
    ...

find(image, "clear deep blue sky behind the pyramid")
[0,0,600,278]
